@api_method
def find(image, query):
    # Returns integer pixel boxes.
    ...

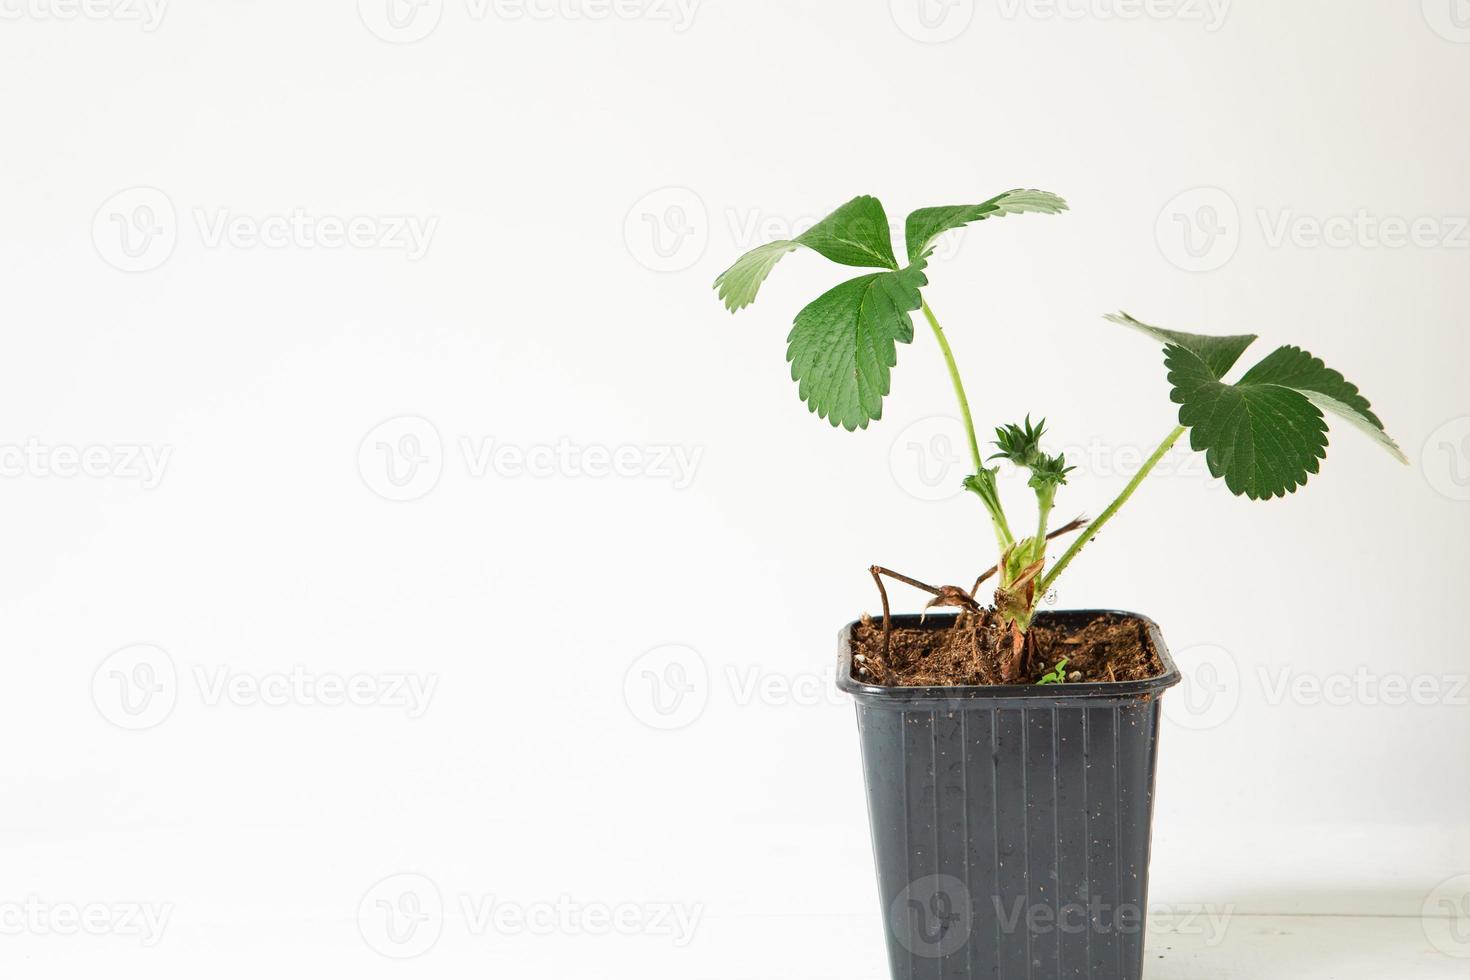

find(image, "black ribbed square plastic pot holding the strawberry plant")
[836,610,1179,980]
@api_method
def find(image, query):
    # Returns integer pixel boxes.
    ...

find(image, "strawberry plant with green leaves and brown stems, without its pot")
[714,190,1408,683]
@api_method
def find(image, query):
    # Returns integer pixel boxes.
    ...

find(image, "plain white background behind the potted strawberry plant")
[0,0,1470,980]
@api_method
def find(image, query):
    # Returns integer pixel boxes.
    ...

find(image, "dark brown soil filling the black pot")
[853,611,1164,688]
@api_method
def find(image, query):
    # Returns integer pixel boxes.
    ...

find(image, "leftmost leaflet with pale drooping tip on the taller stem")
[714,197,898,313]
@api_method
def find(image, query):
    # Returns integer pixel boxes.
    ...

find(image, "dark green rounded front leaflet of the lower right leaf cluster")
[1164,345,1327,500]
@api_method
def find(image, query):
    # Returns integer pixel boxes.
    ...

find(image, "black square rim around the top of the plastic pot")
[836,610,1182,710]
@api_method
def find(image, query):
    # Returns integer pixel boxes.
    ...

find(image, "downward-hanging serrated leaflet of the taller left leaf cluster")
[786,262,929,432]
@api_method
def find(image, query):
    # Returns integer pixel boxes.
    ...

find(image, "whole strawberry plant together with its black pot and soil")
[714,190,1407,980]
